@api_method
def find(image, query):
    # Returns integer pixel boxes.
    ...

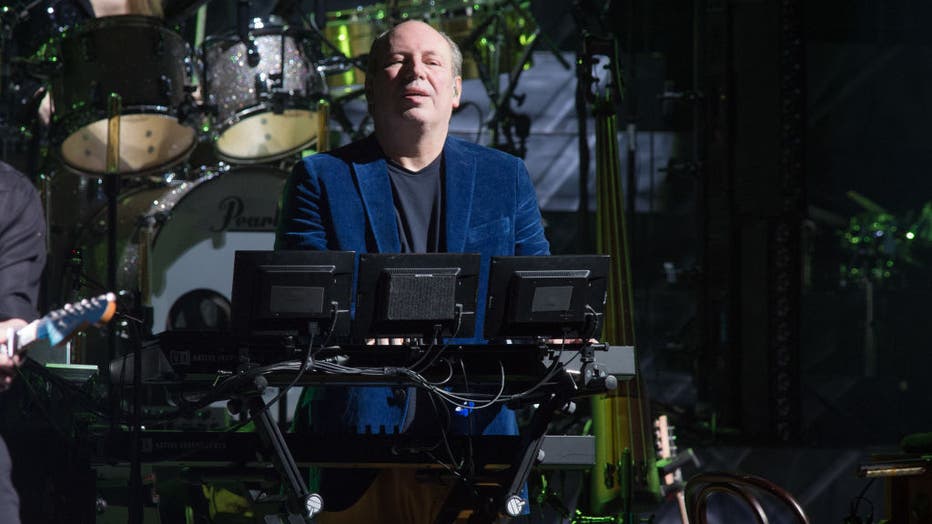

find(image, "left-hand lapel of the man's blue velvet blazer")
[353,152,401,253]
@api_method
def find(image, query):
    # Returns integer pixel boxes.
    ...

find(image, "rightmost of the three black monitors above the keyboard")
[483,255,609,340]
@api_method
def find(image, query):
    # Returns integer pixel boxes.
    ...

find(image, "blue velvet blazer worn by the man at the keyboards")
[276,132,550,434]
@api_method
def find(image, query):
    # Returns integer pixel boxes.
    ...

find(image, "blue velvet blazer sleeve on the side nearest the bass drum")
[275,159,327,251]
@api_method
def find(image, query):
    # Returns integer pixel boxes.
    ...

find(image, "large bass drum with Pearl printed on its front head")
[72,166,287,365]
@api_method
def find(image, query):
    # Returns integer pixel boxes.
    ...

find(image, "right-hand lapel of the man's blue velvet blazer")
[443,138,476,253]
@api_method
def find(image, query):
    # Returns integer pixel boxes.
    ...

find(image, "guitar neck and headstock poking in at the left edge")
[0,293,116,357]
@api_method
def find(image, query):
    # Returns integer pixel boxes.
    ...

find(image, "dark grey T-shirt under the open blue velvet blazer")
[388,155,445,253]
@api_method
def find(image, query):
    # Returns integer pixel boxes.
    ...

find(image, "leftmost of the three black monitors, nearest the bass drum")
[232,251,355,338]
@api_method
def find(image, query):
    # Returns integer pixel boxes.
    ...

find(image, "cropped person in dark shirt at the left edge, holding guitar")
[0,162,45,523]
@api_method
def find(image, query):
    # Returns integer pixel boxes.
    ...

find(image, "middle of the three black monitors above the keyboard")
[353,253,479,342]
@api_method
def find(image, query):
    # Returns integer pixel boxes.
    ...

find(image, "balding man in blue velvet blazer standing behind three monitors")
[276,21,550,522]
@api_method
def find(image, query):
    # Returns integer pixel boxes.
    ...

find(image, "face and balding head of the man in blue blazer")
[366,21,462,133]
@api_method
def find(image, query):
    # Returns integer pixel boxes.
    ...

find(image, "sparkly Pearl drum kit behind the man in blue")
[0,0,532,364]
